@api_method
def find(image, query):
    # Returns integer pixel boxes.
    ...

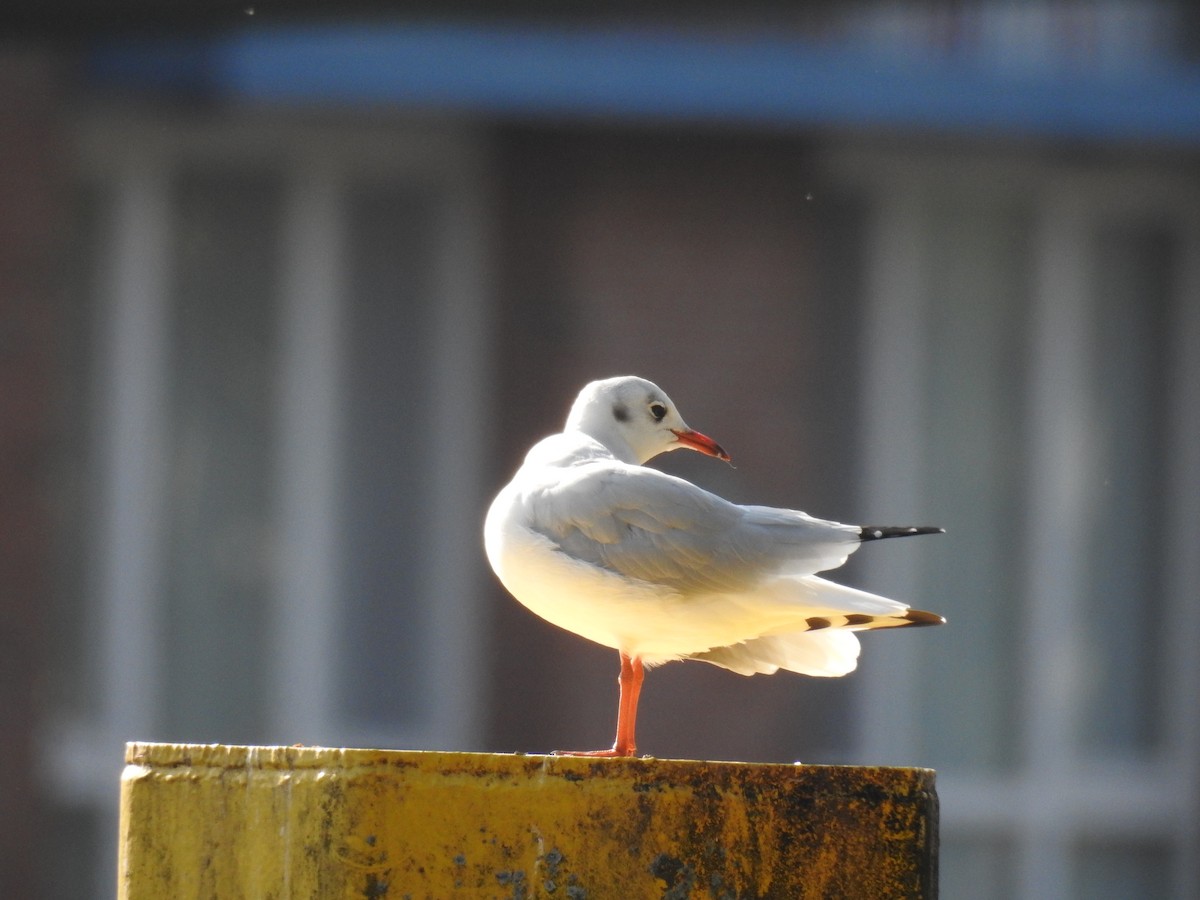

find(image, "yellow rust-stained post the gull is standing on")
[118,744,937,900]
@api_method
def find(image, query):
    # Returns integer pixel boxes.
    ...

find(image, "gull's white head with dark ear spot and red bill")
[566,376,730,463]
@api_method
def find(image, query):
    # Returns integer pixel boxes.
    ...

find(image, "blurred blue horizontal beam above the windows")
[90,24,1200,144]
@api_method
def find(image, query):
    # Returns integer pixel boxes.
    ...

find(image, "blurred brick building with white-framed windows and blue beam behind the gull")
[0,0,1200,900]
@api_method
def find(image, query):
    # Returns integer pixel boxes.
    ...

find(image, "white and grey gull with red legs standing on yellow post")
[484,376,944,756]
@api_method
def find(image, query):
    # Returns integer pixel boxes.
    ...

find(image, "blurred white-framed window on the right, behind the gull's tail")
[845,157,1200,900]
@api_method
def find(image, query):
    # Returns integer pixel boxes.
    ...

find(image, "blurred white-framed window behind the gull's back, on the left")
[46,116,486,895]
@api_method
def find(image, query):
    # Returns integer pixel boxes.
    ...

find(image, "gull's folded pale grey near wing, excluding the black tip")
[529,460,862,594]
